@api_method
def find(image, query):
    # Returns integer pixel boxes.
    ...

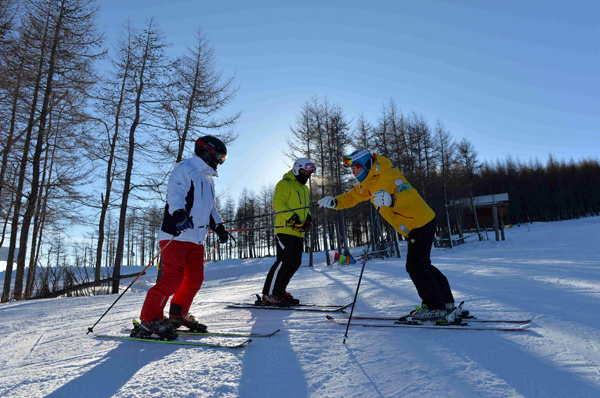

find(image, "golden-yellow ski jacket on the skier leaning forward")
[335,153,435,236]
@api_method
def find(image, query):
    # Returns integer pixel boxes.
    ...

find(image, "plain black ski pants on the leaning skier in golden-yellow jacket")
[406,218,454,309]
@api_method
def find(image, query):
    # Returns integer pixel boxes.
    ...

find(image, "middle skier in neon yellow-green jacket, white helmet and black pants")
[257,158,317,306]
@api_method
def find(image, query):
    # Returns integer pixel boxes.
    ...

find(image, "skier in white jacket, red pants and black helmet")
[133,136,229,340]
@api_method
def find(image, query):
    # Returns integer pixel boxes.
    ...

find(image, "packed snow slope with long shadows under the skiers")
[0,217,600,398]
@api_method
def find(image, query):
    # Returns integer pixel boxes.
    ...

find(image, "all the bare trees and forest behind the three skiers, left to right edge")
[0,0,600,302]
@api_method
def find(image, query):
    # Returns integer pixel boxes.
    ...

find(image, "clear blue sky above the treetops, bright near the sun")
[100,0,600,199]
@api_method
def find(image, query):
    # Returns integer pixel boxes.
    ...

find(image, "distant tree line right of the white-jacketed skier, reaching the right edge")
[228,96,600,257]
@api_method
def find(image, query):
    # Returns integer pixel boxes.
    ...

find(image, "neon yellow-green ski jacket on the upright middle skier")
[273,170,310,238]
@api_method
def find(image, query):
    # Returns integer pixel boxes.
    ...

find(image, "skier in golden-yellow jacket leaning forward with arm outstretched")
[318,149,454,321]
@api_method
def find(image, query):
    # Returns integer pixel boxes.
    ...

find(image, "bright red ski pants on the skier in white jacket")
[140,240,204,322]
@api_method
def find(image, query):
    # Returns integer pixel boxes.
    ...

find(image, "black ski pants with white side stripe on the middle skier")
[263,234,304,295]
